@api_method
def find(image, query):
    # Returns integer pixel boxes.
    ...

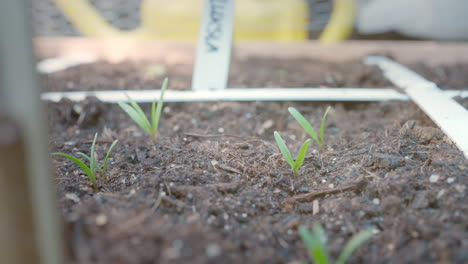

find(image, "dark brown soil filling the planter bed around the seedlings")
[44,57,468,264]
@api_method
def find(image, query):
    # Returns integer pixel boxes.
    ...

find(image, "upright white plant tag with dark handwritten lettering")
[192,0,235,90]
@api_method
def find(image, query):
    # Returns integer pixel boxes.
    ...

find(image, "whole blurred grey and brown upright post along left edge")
[0,0,64,264]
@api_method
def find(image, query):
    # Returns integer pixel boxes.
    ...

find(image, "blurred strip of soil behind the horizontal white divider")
[41,58,392,91]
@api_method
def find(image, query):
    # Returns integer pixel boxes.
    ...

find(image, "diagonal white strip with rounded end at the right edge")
[365,56,468,158]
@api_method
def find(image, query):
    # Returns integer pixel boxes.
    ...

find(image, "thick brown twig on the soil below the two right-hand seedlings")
[283,177,367,209]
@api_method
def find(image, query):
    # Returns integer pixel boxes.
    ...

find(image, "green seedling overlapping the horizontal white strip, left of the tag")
[118,78,168,141]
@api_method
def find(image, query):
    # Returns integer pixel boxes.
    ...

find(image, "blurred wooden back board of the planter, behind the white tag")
[34,37,468,66]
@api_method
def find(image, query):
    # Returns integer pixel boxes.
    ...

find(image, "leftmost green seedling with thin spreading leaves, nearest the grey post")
[53,133,118,187]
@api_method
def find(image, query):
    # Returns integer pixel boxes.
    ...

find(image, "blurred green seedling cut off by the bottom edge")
[299,225,372,264]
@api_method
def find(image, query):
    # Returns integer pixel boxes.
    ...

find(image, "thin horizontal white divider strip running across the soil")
[41,88,468,103]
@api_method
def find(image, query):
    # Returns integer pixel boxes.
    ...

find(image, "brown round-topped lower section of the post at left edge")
[0,116,39,264]
